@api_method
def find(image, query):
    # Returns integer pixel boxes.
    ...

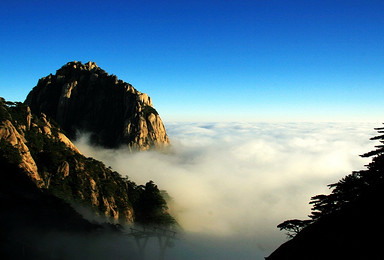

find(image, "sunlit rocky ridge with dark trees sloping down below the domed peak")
[0,98,174,224]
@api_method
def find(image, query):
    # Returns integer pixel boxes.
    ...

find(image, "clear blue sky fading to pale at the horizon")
[0,0,384,122]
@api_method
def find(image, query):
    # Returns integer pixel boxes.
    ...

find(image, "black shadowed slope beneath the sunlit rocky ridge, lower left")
[0,152,137,260]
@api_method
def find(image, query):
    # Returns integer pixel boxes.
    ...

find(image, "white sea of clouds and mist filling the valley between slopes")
[75,123,379,259]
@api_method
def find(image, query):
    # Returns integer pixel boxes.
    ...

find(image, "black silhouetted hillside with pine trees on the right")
[266,125,384,260]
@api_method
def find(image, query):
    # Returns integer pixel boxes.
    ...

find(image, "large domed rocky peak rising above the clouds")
[25,61,169,150]
